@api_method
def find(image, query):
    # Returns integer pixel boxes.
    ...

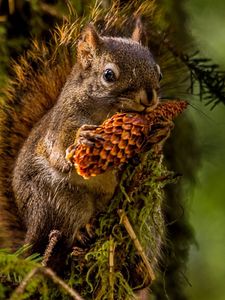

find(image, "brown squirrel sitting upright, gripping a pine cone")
[0,19,161,268]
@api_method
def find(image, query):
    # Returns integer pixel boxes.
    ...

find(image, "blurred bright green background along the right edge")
[186,0,225,300]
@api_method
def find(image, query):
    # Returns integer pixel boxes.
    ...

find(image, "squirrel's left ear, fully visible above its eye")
[77,24,101,69]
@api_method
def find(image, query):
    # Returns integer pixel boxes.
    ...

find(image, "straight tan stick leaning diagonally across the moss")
[118,209,155,281]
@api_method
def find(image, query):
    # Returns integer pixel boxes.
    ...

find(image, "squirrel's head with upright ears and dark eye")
[70,22,161,122]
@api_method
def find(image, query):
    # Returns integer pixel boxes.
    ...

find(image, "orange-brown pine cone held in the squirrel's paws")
[66,100,187,179]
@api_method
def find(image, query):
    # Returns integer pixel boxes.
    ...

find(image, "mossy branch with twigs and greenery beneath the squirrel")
[0,151,174,300]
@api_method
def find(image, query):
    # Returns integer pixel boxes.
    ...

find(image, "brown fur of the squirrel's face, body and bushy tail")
[0,1,159,264]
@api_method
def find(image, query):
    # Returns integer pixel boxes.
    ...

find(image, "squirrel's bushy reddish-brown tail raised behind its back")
[0,24,78,249]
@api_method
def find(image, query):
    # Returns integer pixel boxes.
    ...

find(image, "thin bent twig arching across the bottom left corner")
[9,267,84,300]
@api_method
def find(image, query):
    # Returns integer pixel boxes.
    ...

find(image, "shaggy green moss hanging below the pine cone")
[69,151,177,300]
